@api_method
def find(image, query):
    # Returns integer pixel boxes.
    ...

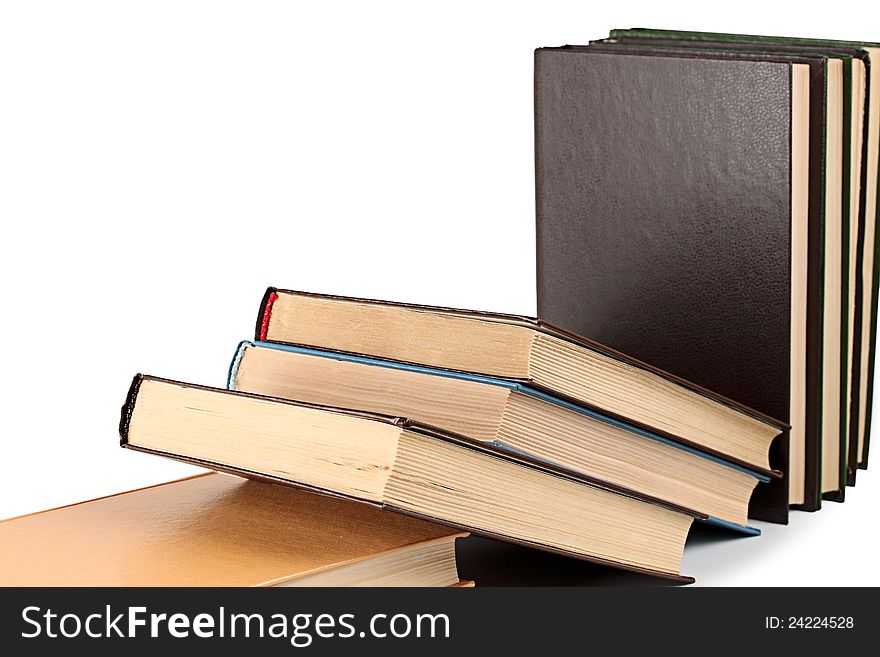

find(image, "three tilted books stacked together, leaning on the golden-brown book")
[121,288,787,580]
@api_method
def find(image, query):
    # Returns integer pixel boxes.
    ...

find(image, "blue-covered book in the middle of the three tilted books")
[227,342,772,534]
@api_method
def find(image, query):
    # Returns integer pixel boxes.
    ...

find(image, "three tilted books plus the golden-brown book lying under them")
[0,288,788,586]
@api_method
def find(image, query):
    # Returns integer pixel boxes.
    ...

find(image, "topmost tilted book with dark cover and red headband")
[256,288,788,520]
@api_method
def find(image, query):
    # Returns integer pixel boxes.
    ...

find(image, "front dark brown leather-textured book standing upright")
[535,47,826,520]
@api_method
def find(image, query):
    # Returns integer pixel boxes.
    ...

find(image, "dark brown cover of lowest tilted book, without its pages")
[119,374,696,583]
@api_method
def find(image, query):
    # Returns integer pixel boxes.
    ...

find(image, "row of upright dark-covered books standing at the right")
[535,29,880,511]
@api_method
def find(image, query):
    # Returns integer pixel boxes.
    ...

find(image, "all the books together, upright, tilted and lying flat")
[0,30,880,586]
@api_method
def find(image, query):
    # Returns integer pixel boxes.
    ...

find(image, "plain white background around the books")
[0,0,880,585]
